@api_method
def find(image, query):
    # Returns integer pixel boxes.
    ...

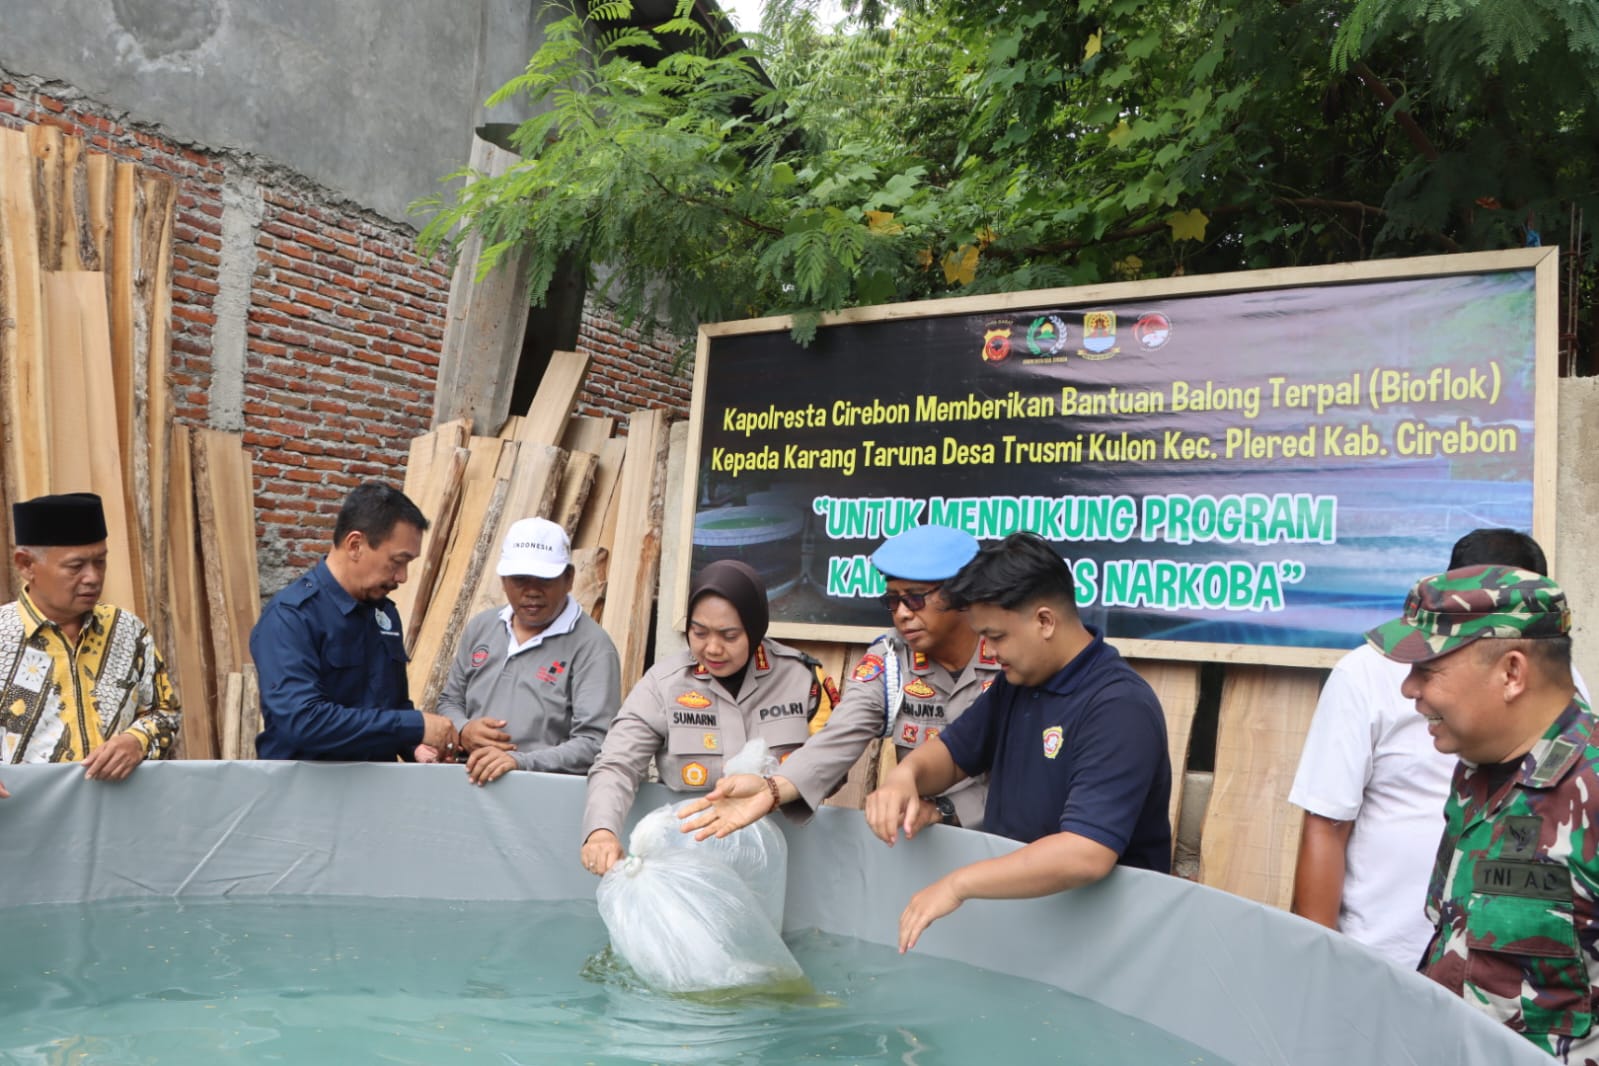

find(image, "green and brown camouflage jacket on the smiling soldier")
[1422,700,1599,1066]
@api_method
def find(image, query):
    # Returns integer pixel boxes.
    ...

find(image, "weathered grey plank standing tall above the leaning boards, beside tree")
[433,137,534,434]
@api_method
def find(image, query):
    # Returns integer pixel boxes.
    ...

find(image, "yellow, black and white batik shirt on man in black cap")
[0,593,179,762]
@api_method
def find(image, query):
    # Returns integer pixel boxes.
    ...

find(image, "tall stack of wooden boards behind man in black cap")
[0,126,261,758]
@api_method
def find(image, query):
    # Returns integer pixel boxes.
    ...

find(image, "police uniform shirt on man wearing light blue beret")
[833,633,999,829]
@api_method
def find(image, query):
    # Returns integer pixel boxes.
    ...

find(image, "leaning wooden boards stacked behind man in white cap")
[395,352,668,710]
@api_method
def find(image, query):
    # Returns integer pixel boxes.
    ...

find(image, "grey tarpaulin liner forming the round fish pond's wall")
[0,762,1551,1066]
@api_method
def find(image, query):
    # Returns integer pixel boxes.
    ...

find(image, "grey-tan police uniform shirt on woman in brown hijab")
[582,639,865,841]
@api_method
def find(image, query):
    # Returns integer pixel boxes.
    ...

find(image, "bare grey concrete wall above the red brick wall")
[0,0,540,219]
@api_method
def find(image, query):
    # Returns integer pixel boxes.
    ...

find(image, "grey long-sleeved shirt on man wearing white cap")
[438,596,622,774]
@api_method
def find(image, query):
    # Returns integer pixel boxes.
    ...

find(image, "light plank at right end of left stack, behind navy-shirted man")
[192,430,261,674]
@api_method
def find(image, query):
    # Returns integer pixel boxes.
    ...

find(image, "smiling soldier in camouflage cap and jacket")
[1366,566,1599,1066]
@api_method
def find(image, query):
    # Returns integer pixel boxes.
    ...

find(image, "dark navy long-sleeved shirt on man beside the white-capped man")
[249,559,422,761]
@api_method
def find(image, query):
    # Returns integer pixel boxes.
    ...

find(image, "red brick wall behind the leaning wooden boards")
[0,70,692,595]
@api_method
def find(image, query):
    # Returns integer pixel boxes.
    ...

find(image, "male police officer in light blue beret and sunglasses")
[833,526,999,829]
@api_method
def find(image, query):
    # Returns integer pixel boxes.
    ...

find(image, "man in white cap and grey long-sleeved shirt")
[438,518,622,785]
